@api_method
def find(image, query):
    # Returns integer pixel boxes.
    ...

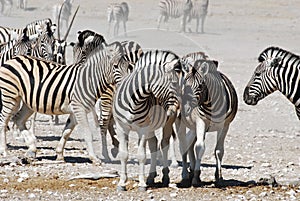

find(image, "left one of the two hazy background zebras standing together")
[157,0,193,32]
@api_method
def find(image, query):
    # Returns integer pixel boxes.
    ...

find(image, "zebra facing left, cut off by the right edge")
[244,47,300,120]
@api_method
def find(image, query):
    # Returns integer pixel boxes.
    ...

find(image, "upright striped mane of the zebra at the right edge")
[258,46,300,62]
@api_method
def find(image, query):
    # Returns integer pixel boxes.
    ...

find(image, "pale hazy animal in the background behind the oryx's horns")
[52,0,73,35]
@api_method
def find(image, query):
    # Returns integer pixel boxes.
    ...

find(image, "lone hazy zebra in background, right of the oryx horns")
[107,2,129,36]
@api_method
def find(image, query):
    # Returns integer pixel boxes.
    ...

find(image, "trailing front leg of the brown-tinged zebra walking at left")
[56,114,76,161]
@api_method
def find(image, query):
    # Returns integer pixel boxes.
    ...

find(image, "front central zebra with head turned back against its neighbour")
[113,50,188,191]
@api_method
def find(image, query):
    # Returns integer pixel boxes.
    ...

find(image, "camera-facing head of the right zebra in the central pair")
[182,58,211,115]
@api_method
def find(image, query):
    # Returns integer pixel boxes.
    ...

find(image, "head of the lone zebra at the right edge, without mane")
[243,52,281,105]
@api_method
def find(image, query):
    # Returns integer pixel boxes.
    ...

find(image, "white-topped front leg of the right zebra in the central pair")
[192,118,205,186]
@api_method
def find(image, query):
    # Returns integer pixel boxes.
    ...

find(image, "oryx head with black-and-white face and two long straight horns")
[53,2,79,64]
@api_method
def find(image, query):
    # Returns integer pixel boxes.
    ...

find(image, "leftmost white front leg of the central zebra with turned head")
[116,121,129,191]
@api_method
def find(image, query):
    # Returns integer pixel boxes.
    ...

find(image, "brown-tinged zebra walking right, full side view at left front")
[0,39,128,163]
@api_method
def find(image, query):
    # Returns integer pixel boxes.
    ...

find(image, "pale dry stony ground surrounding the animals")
[0,0,300,200]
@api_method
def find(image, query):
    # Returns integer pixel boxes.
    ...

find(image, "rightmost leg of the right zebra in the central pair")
[215,125,229,184]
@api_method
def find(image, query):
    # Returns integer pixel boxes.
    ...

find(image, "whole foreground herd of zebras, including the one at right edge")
[0,0,300,191]
